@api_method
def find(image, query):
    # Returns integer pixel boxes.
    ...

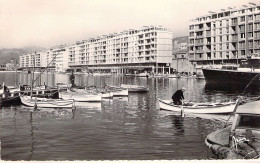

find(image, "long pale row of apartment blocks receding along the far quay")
[20,26,172,73]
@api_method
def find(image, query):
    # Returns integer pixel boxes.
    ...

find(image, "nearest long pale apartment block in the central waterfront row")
[68,26,172,73]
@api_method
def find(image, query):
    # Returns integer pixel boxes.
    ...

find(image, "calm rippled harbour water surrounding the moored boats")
[0,72,260,160]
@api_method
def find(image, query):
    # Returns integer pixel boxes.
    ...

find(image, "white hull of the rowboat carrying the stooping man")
[159,100,235,114]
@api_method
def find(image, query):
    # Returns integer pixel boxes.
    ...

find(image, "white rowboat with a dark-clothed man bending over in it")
[159,99,236,114]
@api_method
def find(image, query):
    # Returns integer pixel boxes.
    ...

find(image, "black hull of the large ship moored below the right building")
[202,69,260,86]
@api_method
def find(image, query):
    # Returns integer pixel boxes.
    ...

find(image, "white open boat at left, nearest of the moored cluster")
[20,96,75,108]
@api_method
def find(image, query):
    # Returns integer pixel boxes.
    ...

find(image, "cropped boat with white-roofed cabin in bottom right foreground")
[205,101,260,159]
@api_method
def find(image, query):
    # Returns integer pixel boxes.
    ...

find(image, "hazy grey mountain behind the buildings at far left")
[0,46,46,64]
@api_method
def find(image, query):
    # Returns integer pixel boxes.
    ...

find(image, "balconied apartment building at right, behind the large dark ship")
[188,3,260,65]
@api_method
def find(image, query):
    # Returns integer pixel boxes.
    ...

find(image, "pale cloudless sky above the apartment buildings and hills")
[0,0,259,48]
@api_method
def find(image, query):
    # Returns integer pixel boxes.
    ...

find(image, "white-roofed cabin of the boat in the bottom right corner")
[229,101,260,151]
